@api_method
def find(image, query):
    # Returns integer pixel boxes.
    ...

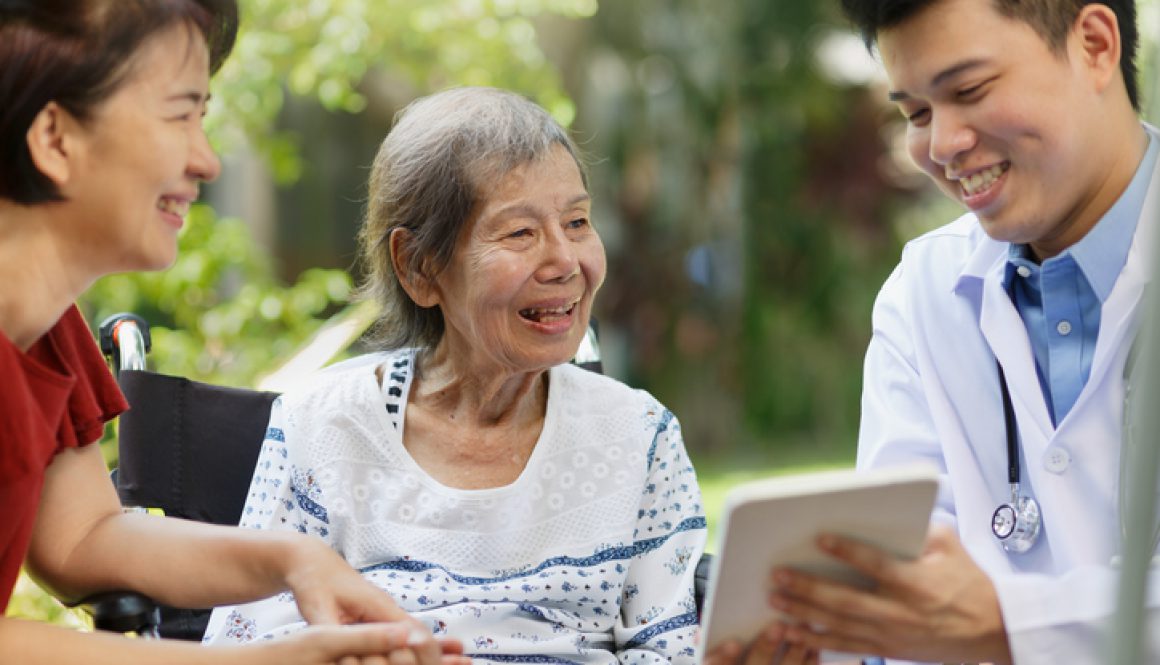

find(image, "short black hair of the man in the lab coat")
[842,0,1140,110]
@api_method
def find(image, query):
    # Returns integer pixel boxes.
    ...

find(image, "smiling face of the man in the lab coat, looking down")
[878,0,1118,259]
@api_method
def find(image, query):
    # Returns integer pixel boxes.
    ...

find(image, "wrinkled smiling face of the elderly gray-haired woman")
[436,146,604,371]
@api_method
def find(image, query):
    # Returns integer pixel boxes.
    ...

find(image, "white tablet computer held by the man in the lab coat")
[701,464,938,662]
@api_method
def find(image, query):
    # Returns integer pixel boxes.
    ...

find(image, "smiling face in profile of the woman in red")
[63,24,220,272]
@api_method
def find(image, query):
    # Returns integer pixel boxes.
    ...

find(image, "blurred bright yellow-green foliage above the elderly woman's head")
[209,0,596,182]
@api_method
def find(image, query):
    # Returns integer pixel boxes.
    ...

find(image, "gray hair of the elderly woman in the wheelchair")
[358,87,588,349]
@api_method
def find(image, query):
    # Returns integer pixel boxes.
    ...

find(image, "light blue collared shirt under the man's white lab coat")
[1003,133,1160,426]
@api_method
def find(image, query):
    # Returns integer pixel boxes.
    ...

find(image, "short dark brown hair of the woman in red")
[0,0,238,205]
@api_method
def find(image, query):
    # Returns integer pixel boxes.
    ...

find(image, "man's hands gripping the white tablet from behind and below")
[705,526,1012,665]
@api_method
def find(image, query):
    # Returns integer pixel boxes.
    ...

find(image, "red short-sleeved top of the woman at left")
[0,306,129,613]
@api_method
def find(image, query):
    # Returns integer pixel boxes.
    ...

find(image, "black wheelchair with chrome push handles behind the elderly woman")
[79,313,711,641]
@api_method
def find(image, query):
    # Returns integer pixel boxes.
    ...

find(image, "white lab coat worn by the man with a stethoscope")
[858,133,1160,665]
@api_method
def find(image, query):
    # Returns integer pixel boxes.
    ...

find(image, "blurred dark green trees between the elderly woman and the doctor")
[566,0,900,458]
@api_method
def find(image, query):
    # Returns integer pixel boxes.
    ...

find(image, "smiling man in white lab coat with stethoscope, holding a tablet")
[756,0,1160,664]
